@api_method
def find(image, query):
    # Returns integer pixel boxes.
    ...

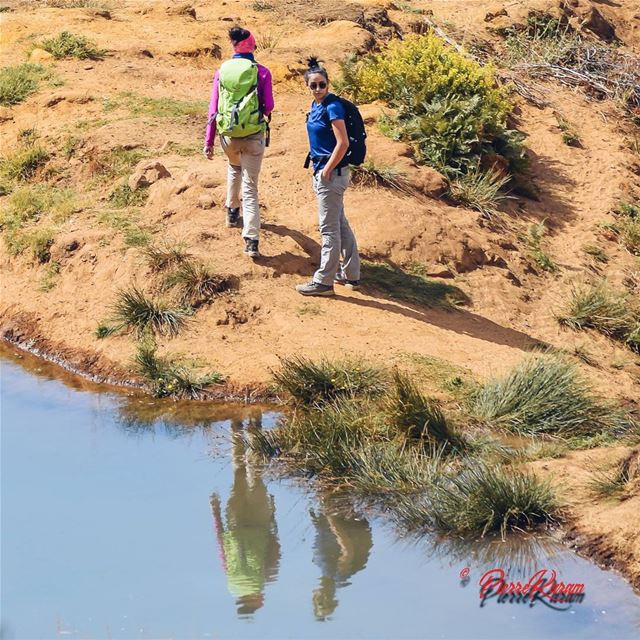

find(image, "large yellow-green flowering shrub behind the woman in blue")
[342,33,523,175]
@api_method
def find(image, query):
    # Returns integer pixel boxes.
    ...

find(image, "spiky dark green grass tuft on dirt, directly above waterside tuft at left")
[112,286,193,336]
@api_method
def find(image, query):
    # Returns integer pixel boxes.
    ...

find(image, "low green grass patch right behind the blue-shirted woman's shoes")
[362,261,469,309]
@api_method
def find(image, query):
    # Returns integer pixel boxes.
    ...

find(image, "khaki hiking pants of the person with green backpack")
[220,132,264,240]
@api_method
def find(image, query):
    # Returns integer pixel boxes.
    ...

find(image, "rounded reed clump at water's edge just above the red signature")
[413,462,559,537]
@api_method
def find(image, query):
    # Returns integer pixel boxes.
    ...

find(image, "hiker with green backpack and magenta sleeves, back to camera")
[204,27,273,258]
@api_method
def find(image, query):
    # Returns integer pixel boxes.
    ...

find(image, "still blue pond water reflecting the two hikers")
[0,348,640,640]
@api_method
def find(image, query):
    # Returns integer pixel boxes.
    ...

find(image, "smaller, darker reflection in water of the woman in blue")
[311,511,373,620]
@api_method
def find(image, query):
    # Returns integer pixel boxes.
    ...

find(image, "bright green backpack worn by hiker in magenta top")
[216,58,265,138]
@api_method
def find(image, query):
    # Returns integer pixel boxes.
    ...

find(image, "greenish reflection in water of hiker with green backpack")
[211,420,280,615]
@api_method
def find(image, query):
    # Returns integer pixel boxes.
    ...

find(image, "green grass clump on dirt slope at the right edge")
[556,282,640,352]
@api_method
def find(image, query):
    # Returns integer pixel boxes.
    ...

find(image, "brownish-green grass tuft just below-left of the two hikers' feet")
[163,260,234,308]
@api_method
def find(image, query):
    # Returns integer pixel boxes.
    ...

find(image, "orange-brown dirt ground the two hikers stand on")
[0,0,640,587]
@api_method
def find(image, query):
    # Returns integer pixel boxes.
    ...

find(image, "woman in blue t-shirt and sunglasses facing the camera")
[296,58,364,296]
